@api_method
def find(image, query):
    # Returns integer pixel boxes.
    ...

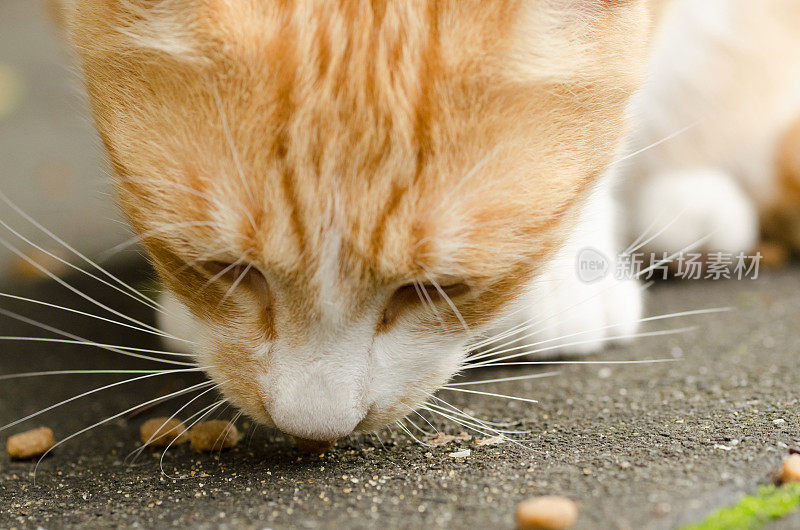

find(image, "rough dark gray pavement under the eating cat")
[0,260,800,528]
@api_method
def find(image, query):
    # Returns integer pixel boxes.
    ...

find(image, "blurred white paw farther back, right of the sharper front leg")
[630,169,759,254]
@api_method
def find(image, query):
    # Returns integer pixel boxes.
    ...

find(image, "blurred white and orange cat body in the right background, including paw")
[622,0,800,254]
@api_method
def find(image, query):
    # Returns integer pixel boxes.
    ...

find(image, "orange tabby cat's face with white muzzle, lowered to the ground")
[67,0,649,441]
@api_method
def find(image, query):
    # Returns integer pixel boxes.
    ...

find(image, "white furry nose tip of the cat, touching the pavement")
[265,360,367,445]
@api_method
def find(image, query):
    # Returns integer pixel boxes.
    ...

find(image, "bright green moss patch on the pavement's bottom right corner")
[683,484,800,530]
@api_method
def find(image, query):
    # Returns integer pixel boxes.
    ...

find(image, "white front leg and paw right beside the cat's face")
[482,179,643,360]
